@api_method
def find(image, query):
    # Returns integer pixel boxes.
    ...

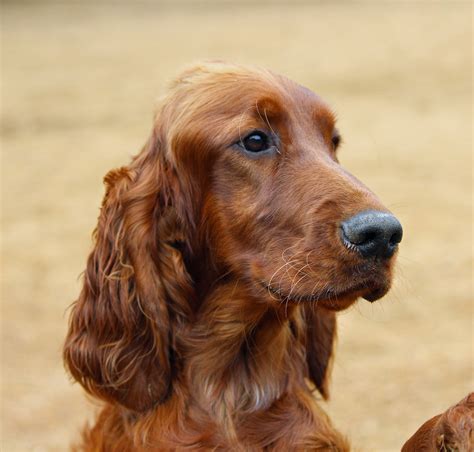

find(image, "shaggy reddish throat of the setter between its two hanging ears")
[186,281,304,427]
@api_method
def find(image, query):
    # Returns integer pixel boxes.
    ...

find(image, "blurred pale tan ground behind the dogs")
[1,0,473,451]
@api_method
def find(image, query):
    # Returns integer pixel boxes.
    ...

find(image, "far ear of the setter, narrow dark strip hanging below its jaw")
[303,304,336,399]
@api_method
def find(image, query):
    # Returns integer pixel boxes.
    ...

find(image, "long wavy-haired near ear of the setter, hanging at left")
[64,132,193,411]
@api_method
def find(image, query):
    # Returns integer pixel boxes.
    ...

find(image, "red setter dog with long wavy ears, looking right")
[64,62,408,451]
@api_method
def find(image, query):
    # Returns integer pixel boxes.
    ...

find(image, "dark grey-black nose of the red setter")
[341,210,403,258]
